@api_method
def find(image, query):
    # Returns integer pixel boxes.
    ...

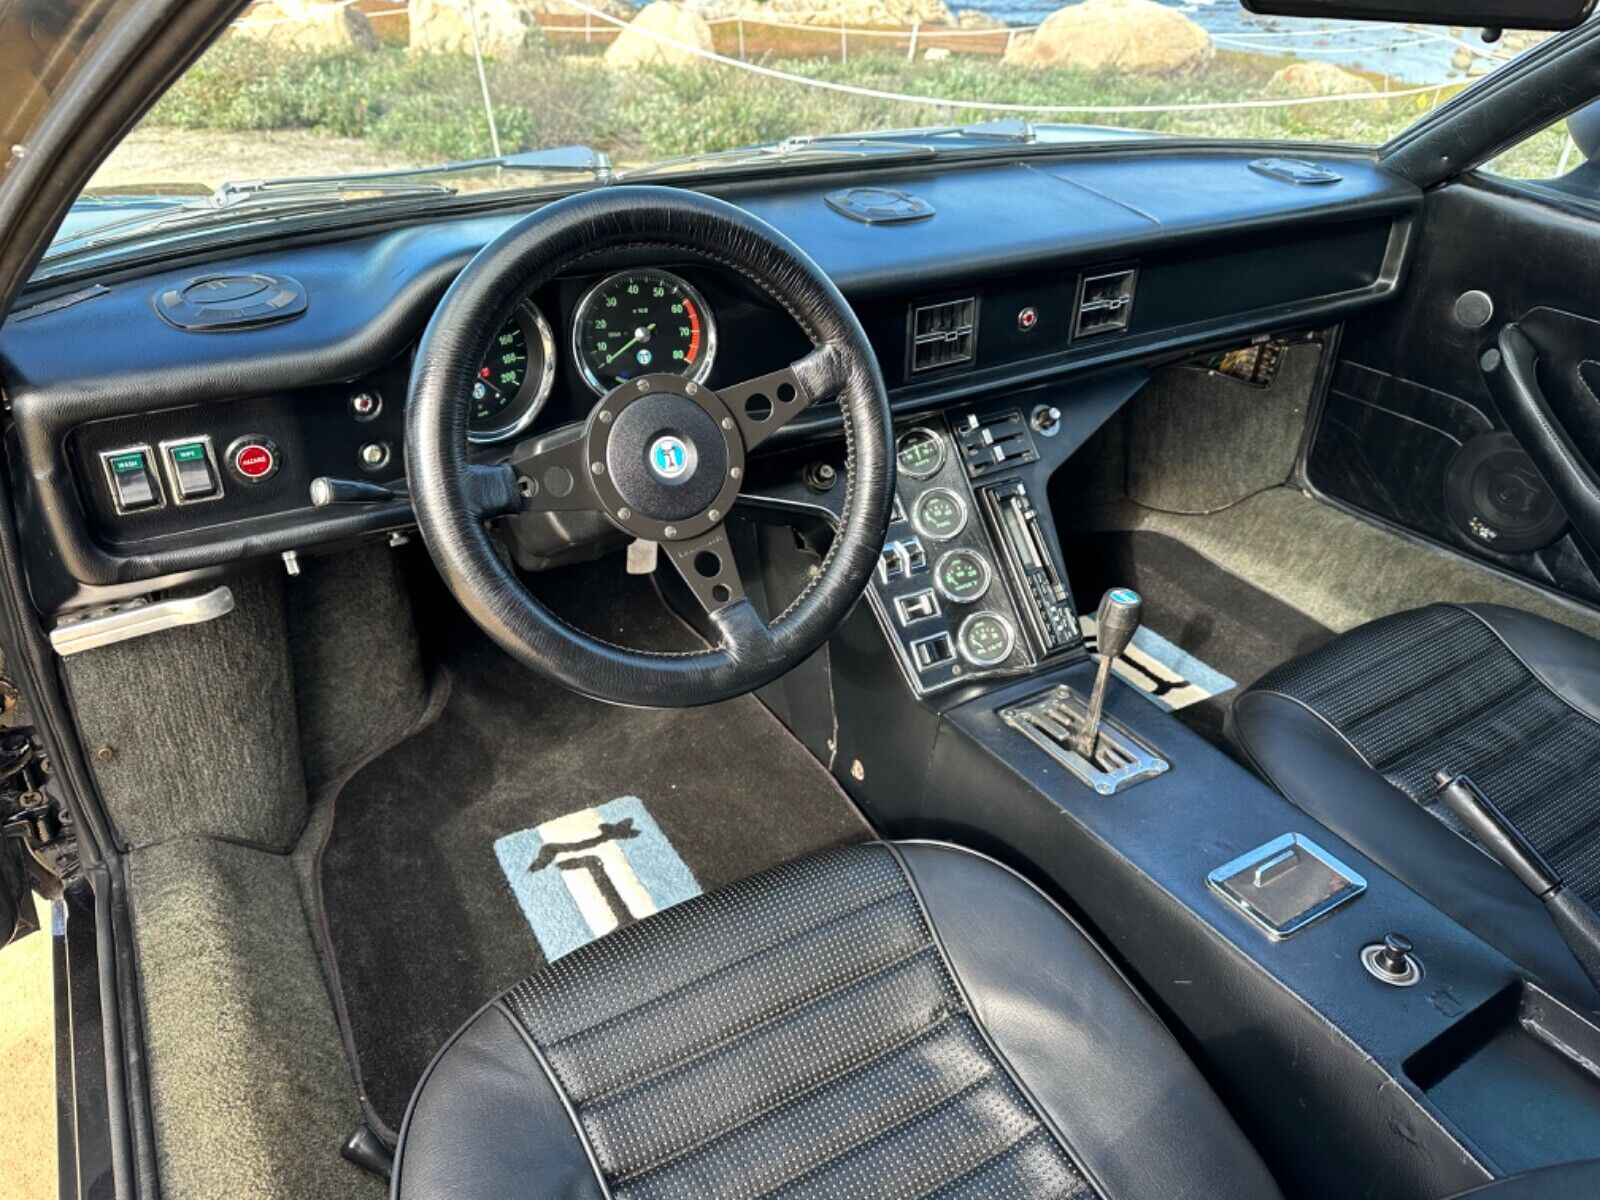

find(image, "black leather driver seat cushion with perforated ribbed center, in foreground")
[394,842,1278,1200]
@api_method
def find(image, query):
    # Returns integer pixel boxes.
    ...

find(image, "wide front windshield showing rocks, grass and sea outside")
[54,0,1562,258]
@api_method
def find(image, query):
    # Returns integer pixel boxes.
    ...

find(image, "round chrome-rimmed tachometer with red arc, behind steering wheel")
[573,270,717,395]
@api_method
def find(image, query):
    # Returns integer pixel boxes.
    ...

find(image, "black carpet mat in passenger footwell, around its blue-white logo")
[1064,531,1333,746]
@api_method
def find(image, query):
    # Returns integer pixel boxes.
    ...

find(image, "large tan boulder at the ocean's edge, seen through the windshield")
[1005,0,1211,75]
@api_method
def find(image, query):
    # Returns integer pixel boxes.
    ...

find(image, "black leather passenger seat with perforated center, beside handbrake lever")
[1229,605,1600,1008]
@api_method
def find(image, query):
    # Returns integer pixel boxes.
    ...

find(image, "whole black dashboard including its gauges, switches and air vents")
[0,147,1421,614]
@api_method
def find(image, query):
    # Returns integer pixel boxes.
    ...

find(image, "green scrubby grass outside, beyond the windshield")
[147,38,1562,176]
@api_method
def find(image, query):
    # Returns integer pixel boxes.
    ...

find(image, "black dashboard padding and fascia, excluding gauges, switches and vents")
[0,146,1421,608]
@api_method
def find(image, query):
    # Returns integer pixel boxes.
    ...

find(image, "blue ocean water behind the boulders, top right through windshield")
[950,0,1490,83]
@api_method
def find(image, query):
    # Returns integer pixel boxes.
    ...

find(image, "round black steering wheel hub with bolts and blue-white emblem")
[602,390,742,536]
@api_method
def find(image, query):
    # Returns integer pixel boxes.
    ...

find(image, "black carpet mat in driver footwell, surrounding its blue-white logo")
[322,557,870,1131]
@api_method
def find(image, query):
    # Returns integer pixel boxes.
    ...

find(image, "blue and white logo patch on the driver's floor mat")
[494,795,701,960]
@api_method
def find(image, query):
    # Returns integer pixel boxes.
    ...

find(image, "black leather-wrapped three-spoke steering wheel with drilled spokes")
[406,187,894,707]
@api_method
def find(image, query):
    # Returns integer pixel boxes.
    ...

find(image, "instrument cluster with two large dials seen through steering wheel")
[467,267,745,445]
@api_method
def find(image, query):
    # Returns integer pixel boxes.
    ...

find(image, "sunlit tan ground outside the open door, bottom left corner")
[0,904,56,1200]
